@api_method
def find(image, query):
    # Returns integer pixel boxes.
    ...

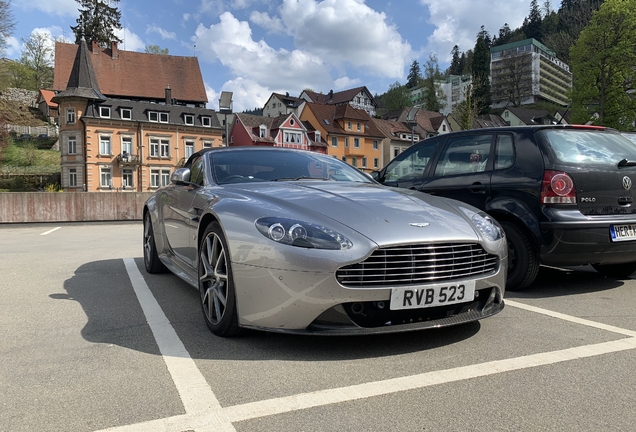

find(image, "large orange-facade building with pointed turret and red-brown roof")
[52,41,224,192]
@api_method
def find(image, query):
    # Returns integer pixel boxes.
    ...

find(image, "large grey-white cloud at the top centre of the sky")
[280,0,413,78]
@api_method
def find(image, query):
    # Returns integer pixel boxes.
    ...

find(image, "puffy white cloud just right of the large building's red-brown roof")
[193,12,332,92]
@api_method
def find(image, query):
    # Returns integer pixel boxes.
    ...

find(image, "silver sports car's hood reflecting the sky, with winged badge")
[226,181,479,245]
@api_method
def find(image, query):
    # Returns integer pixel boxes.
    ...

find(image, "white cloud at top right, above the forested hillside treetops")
[420,0,536,62]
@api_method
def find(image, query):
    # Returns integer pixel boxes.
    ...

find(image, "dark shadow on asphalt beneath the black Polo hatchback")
[505,266,625,299]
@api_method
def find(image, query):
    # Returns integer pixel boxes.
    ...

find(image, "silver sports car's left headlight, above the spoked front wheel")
[256,217,353,250]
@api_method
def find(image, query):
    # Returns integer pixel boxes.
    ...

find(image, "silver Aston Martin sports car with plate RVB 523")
[143,147,508,336]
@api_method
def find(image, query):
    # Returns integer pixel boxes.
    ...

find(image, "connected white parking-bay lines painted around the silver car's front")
[110,259,636,432]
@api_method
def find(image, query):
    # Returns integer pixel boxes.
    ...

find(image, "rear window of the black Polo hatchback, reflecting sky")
[538,129,636,165]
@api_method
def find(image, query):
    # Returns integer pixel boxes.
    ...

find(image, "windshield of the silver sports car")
[212,149,372,184]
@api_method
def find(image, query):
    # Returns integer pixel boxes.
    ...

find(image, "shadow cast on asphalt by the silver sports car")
[50,259,481,361]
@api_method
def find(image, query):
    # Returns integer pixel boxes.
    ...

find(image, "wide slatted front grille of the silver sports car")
[336,243,499,287]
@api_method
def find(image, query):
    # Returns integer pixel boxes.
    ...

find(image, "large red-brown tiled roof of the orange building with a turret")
[53,42,208,103]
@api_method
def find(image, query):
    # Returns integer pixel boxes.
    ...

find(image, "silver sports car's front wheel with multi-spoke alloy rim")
[199,222,241,337]
